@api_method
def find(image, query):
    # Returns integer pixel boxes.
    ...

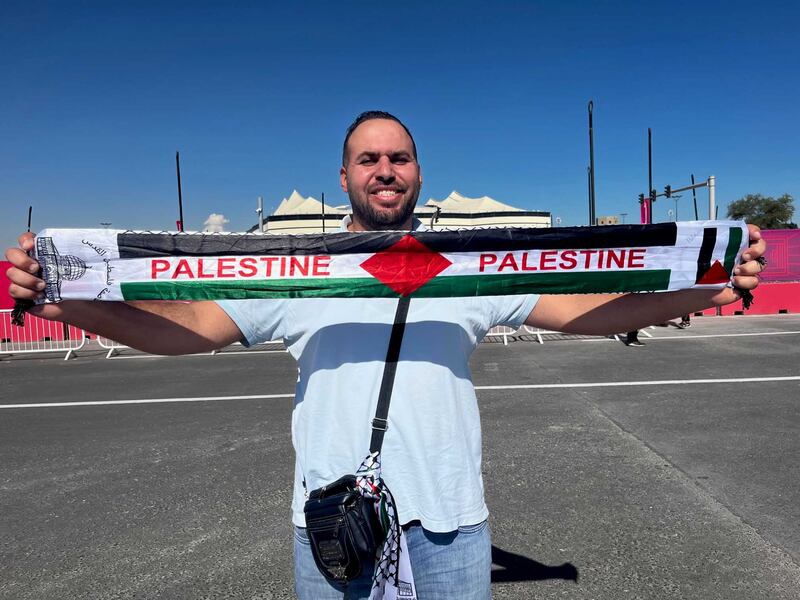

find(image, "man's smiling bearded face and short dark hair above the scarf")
[339,119,422,231]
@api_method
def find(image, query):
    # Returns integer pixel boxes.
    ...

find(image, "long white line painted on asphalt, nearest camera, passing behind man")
[0,375,800,409]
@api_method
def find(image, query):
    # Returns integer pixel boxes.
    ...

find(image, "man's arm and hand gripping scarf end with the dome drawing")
[6,233,242,354]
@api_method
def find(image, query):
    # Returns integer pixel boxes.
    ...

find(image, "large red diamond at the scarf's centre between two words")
[361,235,453,296]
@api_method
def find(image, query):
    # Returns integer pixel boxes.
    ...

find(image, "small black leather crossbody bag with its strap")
[304,296,411,585]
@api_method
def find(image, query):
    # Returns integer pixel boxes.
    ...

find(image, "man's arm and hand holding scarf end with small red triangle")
[525,225,766,335]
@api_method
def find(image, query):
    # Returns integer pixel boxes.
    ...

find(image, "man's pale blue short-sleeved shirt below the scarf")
[218,219,538,532]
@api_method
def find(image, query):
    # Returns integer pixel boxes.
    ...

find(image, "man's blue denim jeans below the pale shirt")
[294,521,492,600]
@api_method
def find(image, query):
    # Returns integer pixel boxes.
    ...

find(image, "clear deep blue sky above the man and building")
[0,0,800,246]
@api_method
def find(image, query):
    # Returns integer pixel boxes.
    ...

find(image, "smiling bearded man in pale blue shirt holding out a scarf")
[6,112,765,600]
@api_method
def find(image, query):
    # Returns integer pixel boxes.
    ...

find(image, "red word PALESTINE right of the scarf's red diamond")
[479,248,647,273]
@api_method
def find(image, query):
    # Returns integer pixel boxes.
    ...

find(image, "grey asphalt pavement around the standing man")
[0,315,800,600]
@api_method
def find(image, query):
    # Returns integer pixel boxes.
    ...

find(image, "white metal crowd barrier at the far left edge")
[0,309,86,360]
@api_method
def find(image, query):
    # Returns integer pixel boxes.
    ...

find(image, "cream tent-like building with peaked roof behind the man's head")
[256,190,552,233]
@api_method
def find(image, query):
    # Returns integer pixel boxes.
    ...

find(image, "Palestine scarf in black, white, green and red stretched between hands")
[26,221,749,302]
